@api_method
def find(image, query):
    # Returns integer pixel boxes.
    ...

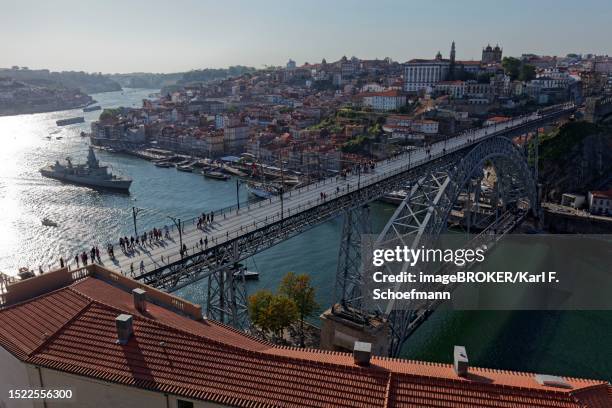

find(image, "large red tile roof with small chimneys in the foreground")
[0,277,612,408]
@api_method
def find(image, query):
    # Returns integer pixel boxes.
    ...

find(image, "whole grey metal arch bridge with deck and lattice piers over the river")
[94,104,576,353]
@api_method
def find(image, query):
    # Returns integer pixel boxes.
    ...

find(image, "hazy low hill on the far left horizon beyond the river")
[0,67,121,94]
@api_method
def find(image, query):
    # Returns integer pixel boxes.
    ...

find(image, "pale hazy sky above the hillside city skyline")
[0,0,612,73]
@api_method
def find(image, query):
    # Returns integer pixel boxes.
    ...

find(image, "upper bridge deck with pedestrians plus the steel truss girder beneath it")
[93,104,576,290]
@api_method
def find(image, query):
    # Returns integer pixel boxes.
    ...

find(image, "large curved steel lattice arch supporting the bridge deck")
[374,136,538,356]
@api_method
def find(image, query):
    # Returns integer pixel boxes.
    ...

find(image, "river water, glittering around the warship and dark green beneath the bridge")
[0,89,612,380]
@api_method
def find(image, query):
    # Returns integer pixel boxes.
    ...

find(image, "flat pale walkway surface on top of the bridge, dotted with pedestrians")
[83,106,573,275]
